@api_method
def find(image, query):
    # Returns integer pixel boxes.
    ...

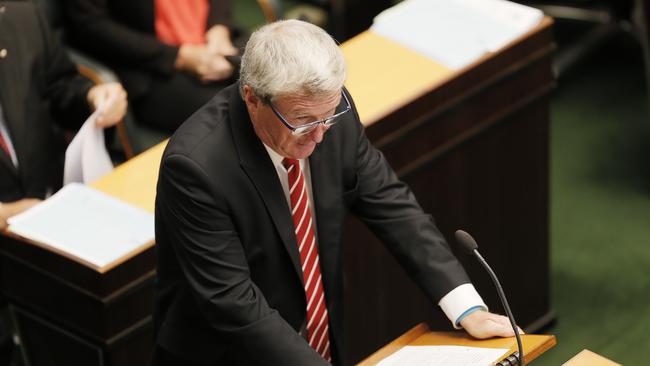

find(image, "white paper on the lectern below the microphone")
[377,346,509,366]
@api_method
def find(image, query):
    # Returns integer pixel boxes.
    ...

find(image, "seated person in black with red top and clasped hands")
[64,0,239,133]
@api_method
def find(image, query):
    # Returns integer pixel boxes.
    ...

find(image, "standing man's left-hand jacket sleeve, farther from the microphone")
[156,154,328,365]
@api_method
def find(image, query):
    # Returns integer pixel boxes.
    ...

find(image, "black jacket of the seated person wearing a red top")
[63,0,231,99]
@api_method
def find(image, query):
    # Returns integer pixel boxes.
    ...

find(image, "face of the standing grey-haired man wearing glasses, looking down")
[244,85,341,159]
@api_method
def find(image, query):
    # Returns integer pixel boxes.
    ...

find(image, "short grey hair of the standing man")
[239,20,346,101]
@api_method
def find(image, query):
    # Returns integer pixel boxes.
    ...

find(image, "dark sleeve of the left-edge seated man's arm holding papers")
[35,8,92,130]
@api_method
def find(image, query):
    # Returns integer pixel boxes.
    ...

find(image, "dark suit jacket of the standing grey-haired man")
[155,85,469,365]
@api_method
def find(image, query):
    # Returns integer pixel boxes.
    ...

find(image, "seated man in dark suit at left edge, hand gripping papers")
[0,1,126,365]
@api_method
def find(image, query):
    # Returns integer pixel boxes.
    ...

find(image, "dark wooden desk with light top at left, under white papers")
[0,144,164,366]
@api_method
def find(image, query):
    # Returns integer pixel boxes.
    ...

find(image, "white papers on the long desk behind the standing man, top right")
[371,0,544,69]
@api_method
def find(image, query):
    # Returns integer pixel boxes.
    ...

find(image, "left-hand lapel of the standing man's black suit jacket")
[230,92,303,282]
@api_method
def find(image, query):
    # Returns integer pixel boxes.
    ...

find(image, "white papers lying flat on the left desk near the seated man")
[8,183,154,267]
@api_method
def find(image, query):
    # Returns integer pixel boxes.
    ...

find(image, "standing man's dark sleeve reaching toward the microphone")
[346,106,470,304]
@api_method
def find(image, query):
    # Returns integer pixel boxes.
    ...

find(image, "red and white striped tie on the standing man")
[282,158,331,361]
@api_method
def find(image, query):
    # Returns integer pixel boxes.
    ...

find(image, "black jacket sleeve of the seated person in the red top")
[64,0,178,75]
